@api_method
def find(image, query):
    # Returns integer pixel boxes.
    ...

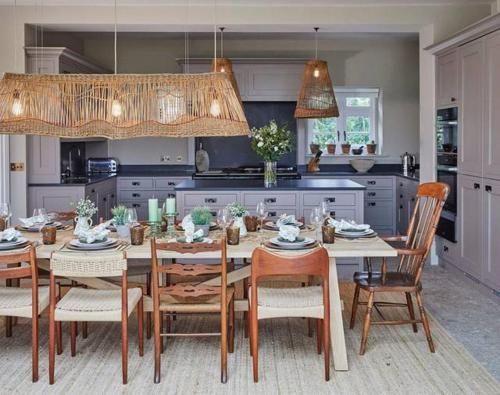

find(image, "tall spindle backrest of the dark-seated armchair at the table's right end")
[398,182,450,283]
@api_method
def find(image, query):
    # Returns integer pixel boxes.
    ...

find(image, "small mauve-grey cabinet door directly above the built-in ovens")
[436,51,458,107]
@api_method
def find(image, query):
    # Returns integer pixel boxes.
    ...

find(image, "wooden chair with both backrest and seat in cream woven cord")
[49,252,144,384]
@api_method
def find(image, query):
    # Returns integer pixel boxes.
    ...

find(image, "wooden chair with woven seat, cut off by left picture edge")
[0,245,49,382]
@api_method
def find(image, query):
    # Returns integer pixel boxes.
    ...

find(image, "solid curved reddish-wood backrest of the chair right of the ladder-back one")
[252,247,329,284]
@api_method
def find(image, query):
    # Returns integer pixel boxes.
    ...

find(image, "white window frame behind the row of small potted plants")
[305,87,382,154]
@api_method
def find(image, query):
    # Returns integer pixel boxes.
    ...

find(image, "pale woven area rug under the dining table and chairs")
[0,284,500,394]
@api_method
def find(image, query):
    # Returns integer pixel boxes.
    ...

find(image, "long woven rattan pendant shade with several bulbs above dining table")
[0,73,249,139]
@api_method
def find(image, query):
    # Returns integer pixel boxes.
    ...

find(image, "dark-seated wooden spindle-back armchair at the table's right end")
[350,182,450,355]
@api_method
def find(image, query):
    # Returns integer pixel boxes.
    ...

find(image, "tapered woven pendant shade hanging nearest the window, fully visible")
[295,60,339,118]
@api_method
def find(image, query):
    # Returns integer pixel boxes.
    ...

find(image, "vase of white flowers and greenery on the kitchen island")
[251,120,293,187]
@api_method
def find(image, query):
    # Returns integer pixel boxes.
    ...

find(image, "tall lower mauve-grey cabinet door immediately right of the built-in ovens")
[458,175,484,279]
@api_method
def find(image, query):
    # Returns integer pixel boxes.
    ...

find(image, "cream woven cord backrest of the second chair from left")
[50,251,127,277]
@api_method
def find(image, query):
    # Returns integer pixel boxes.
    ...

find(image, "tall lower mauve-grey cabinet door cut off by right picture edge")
[482,180,500,291]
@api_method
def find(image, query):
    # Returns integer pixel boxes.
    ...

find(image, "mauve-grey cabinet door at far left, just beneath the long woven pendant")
[27,136,61,184]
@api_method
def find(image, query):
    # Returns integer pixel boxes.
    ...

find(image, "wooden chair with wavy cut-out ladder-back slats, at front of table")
[151,237,234,383]
